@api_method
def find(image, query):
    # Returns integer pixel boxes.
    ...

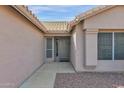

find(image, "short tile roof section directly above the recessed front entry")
[42,21,69,33]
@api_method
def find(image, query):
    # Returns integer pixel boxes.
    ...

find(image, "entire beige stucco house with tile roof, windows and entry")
[0,5,124,87]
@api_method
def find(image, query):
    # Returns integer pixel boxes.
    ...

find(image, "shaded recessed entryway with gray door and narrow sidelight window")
[45,36,70,62]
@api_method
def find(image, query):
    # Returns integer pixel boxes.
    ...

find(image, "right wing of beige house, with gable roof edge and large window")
[71,5,124,71]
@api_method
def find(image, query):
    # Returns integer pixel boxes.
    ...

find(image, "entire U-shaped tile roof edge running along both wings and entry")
[12,5,116,33]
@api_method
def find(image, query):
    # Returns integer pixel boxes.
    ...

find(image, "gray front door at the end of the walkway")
[55,37,70,62]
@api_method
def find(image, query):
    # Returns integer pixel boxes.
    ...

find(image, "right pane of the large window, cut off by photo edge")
[114,33,124,60]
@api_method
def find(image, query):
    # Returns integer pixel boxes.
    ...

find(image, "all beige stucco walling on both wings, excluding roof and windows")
[0,6,124,87]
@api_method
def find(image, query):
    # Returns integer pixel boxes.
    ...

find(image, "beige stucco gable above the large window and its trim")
[84,6,124,29]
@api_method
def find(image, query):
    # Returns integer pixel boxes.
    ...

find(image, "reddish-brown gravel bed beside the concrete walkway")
[54,72,124,88]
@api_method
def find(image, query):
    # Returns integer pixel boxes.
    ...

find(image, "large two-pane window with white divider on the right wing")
[98,32,124,60]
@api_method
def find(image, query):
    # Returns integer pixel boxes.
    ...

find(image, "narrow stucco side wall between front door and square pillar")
[71,23,85,71]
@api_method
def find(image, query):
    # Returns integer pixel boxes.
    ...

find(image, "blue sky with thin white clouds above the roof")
[28,5,96,21]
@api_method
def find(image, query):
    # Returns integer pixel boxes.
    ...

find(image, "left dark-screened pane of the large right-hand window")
[98,33,112,60]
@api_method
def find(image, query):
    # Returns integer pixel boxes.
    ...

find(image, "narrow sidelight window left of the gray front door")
[46,38,52,58]
